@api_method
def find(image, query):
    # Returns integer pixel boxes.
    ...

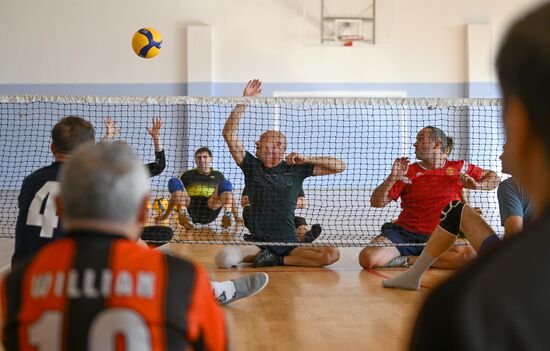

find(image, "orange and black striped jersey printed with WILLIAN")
[0,231,227,351]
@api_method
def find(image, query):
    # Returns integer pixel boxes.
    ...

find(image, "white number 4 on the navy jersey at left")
[27,181,59,238]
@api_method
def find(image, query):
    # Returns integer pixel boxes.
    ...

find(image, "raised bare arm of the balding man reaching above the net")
[222,79,262,165]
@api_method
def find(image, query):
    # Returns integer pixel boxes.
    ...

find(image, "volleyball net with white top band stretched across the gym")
[0,96,504,246]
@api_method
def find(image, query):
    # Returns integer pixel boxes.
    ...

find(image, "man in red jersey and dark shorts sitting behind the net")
[359,126,500,269]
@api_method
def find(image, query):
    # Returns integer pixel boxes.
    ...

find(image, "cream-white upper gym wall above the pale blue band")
[0,0,542,84]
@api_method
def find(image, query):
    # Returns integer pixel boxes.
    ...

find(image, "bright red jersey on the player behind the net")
[389,160,483,235]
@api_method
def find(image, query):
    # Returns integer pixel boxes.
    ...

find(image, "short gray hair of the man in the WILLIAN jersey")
[60,143,149,224]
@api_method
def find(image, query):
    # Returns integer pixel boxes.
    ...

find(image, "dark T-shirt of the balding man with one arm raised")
[240,152,314,242]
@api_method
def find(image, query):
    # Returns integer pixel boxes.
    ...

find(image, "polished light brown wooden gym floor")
[0,240,458,351]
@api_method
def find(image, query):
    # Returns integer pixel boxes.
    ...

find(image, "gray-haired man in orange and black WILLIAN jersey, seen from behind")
[0,144,227,350]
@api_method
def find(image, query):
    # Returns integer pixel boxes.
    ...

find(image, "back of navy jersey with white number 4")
[12,162,64,264]
